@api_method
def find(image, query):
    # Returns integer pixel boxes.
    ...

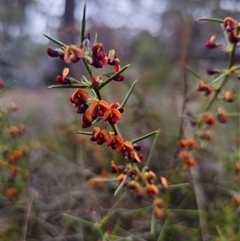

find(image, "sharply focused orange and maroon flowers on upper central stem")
[47,34,145,162]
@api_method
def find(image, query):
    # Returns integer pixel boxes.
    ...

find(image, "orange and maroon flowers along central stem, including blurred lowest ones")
[47,31,163,218]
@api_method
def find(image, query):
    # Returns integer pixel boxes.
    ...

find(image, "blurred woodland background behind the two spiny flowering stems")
[0,0,240,241]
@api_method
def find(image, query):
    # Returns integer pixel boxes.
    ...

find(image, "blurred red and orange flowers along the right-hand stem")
[177,17,240,170]
